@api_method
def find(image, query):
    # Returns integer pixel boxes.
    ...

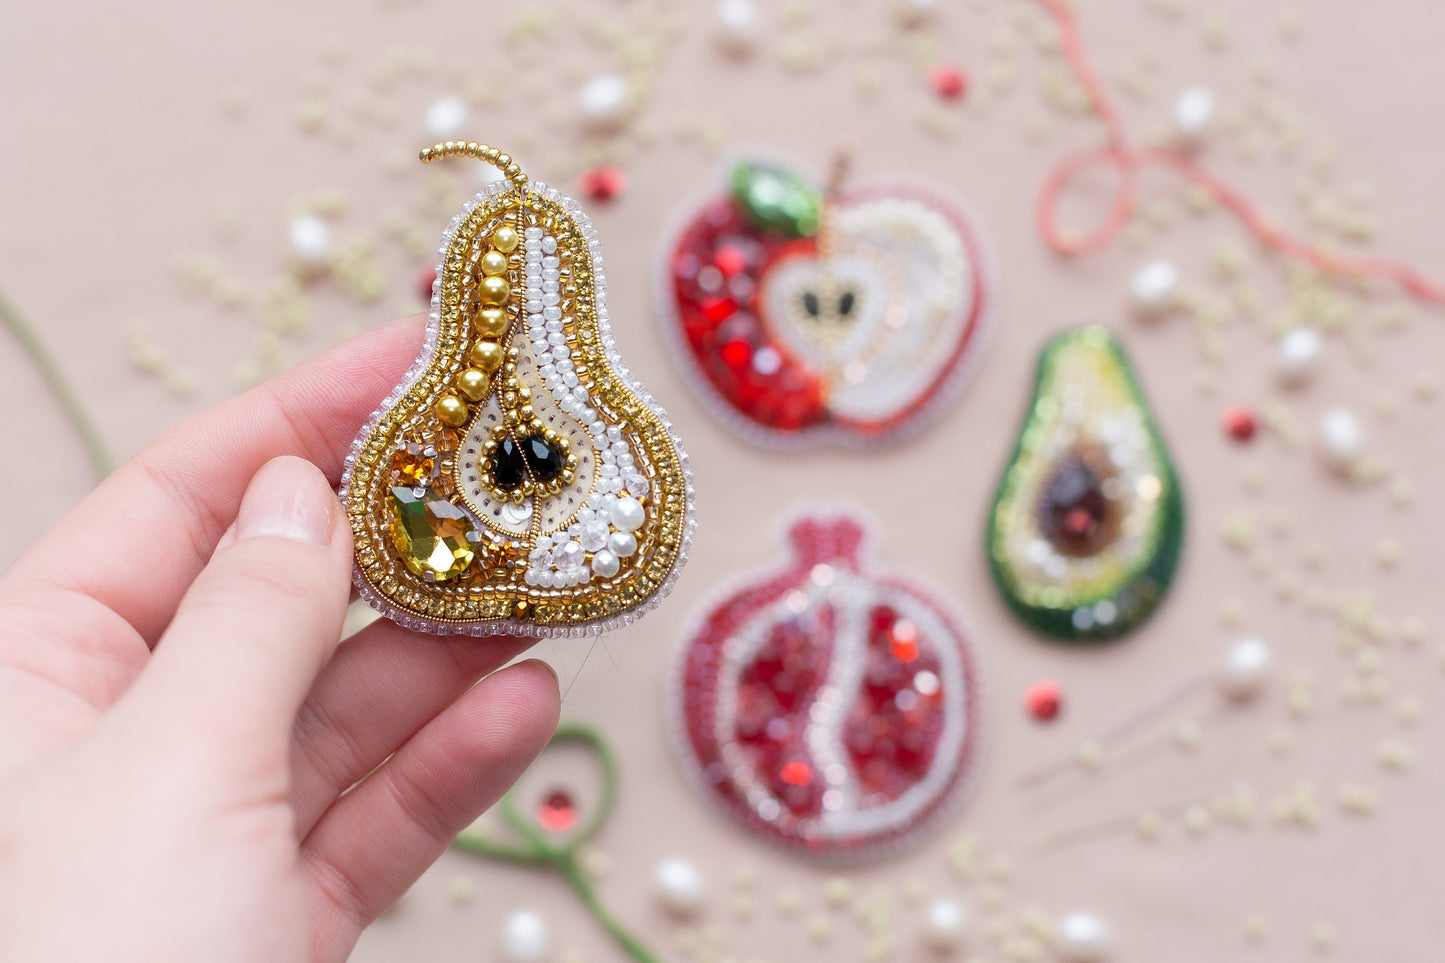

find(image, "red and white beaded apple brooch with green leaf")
[657,163,993,442]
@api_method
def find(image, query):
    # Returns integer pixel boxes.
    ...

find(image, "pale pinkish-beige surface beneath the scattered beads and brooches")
[0,0,1445,963]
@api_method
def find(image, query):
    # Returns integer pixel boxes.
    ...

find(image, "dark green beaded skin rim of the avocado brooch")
[987,325,1185,643]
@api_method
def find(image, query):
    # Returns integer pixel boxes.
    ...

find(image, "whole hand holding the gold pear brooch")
[0,320,559,963]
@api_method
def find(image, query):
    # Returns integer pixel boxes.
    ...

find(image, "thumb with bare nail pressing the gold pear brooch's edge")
[117,457,351,766]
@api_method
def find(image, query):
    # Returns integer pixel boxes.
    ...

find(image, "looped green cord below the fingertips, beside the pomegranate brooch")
[454,722,659,963]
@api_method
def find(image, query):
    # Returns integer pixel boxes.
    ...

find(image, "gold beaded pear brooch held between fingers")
[341,142,694,636]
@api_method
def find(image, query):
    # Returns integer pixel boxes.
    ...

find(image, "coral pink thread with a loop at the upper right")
[1038,0,1445,304]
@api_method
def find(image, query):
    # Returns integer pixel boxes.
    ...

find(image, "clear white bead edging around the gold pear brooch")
[337,179,698,639]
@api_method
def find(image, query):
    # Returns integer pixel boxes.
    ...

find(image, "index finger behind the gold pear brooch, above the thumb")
[7,315,425,643]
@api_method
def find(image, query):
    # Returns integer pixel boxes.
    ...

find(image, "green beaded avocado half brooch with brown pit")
[988,325,1183,641]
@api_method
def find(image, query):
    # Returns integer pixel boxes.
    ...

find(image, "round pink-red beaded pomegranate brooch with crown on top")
[669,516,980,859]
